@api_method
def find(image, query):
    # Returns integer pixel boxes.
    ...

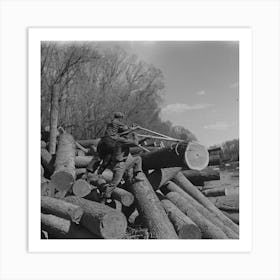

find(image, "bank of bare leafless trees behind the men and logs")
[41,42,196,151]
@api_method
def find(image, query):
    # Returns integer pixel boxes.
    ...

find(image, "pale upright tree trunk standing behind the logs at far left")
[49,86,59,155]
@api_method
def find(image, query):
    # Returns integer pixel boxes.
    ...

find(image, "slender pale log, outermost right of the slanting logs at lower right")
[172,172,239,234]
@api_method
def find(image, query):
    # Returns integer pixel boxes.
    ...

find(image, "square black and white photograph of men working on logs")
[38,40,240,242]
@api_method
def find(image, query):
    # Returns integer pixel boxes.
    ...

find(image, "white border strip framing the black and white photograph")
[28,28,252,252]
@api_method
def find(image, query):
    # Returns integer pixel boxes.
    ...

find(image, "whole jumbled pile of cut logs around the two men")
[41,132,239,239]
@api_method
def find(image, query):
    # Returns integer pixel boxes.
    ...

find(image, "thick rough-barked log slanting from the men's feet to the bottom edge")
[127,174,178,239]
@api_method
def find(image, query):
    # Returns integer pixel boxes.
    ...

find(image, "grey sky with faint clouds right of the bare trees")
[100,41,239,146]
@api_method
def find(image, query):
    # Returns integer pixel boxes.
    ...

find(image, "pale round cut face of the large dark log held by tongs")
[185,142,209,171]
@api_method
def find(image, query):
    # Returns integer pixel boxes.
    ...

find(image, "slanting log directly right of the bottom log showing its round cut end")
[166,192,228,239]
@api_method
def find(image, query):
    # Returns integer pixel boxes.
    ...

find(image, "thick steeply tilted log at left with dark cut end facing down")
[51,133,76,192]
